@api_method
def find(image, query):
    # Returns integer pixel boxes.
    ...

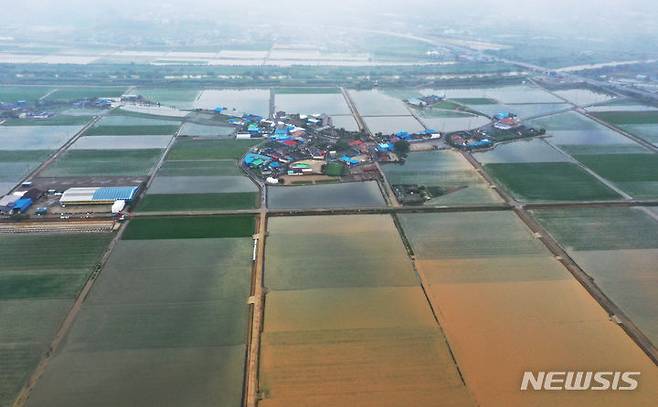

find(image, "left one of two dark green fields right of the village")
[484,162,621,201]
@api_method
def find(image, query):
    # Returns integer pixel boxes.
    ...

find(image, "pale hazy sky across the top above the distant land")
[3,0,658,41]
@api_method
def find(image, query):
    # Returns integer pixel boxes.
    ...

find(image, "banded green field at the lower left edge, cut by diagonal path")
[0,233,112,406]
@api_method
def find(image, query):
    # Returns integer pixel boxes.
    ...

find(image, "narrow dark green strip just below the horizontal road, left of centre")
[123,216,255,240]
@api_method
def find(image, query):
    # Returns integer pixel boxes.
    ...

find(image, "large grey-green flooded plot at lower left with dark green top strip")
[27,218,253,407]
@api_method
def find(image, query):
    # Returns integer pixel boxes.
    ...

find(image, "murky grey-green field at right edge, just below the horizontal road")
[533,208,658,250]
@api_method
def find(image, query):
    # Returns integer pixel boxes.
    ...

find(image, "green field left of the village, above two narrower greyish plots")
[167,138,260,160]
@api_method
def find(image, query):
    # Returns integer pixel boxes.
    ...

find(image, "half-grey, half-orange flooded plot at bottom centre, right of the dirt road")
[259,215,475,407]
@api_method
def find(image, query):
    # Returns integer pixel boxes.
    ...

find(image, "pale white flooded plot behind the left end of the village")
[194,89,270,117]
